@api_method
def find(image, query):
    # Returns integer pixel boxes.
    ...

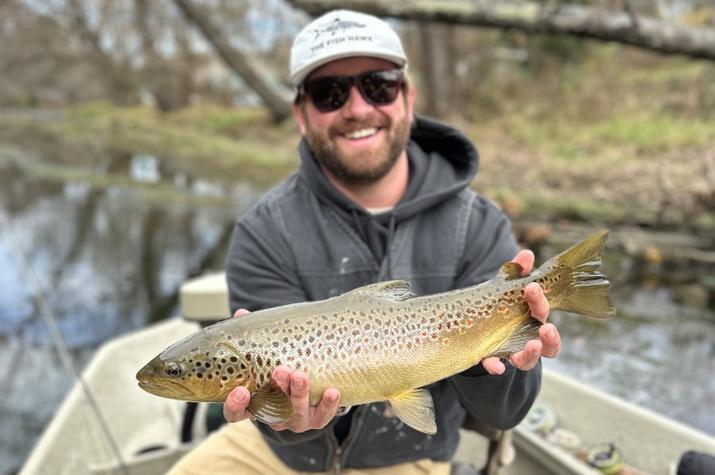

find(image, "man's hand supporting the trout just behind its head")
[223,309,340,432]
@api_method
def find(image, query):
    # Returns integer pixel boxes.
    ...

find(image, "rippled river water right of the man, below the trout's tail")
[546,256,715,434]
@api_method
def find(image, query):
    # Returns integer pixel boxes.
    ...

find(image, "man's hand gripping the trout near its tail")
[482,250,561,374]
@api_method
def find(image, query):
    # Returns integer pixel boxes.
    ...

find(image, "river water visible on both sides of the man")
[0,142,715,475]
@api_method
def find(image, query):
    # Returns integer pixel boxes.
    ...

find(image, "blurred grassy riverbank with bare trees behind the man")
[0,0,715,234]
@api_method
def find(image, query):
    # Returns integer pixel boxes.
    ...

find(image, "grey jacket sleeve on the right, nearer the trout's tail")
[450,196,541,430]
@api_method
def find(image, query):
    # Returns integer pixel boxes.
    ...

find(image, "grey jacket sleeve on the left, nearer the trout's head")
[226,209,332,445]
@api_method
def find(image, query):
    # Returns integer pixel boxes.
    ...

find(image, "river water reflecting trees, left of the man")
[0,148,258,474]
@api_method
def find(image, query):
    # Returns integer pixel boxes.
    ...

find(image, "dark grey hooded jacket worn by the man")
[227,117,541,471]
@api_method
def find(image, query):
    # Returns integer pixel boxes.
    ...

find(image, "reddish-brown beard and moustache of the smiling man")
[305,112,410,185]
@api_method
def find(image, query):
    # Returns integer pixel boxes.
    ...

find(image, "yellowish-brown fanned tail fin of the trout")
[544,230,616,318]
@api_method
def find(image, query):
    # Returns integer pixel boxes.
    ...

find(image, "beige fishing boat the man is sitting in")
[20,273,715,475]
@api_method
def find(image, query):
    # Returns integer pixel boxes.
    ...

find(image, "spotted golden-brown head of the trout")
[136,330,249,402]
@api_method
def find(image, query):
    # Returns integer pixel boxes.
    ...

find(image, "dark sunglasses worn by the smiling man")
[301,69,405,112]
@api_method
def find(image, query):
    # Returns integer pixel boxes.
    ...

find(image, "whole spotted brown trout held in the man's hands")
[137,231,615,434]
